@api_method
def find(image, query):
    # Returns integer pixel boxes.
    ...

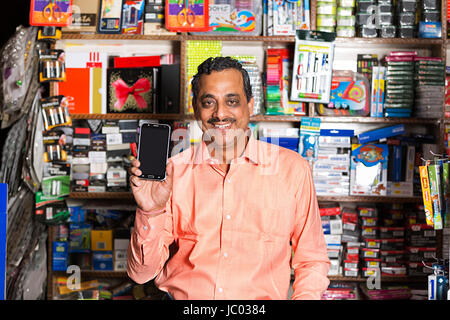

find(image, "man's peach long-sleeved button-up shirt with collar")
[127,132,330,300]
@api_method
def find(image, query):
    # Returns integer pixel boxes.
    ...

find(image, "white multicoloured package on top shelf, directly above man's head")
[194,0,263,36]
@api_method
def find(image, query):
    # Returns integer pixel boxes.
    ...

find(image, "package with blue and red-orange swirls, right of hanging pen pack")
[316,71,370,117]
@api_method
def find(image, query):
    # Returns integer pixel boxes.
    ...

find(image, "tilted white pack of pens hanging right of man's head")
[291,30,336,103]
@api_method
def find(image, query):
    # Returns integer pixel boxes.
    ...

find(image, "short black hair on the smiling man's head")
[192,57,253,108]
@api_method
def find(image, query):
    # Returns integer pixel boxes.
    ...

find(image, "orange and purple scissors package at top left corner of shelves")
[30,0,72,27]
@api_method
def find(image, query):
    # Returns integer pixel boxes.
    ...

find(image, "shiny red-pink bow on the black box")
[111,78,151,110]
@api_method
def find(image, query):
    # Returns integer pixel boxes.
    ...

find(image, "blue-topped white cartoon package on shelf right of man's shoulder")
[350,143,389,196]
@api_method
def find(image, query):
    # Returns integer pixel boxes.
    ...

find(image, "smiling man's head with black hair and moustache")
[192,57,254,147]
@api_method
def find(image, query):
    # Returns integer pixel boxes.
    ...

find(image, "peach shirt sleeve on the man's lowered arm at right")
[291,160,330,300]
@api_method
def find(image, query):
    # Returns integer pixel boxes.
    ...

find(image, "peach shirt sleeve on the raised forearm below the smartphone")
[127,200,174,284]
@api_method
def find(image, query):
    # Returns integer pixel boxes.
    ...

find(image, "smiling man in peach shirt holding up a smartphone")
[127,57,330,300]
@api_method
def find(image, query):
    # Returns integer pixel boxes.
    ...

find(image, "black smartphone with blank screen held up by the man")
[137,123,170,181]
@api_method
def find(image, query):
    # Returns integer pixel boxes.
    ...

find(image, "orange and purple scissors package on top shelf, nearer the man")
[165,0,209,32]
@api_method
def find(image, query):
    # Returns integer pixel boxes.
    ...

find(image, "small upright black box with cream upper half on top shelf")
[97,0,123,34]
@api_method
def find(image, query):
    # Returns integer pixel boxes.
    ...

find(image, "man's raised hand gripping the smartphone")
[130,159,173,211]
